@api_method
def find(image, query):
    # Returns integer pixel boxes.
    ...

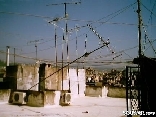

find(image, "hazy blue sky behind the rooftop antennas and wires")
[0,0,156,69]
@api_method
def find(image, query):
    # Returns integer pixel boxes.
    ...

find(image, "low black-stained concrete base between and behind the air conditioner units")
[8,90,61,107]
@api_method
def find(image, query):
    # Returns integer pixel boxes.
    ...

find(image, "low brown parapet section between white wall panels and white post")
[85,86,108,97]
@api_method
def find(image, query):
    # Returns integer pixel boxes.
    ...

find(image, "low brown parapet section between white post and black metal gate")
[108,86,126,98]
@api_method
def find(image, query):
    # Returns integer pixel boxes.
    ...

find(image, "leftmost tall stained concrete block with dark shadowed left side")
[6,64,39,91]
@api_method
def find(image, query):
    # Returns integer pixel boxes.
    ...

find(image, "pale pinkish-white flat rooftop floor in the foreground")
[0,97,126,117]
